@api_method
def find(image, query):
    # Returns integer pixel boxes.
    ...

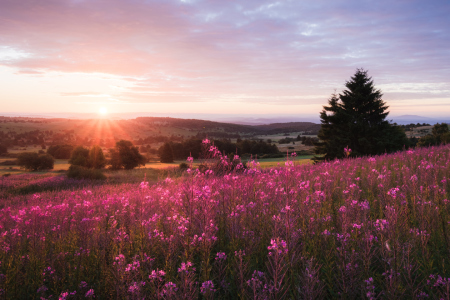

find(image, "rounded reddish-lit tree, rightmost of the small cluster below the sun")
[109,140,145,170]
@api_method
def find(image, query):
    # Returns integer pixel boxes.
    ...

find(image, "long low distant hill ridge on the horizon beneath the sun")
[0,116,320,147]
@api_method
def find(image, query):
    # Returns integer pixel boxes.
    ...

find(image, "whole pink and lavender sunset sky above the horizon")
[0,0,450,117]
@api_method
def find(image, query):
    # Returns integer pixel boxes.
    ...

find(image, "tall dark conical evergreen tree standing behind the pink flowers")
[314,69,408,161]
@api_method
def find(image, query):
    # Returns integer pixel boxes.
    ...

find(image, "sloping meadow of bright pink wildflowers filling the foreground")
[0,146,450,299]
